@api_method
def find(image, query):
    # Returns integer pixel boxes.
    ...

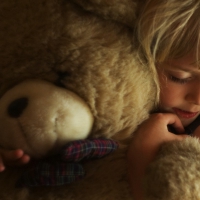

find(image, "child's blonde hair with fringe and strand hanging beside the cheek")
[136,0,200,101]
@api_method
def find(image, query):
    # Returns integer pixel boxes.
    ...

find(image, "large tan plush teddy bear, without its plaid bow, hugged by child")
[0,0,200,200]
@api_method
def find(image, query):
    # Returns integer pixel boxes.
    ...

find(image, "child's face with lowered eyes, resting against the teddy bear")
[158,54,200,126]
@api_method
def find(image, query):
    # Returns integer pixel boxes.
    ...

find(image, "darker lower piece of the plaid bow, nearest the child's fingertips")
[16,162,85,187]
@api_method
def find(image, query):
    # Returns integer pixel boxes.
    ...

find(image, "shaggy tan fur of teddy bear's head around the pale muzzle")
[0,0,155,140]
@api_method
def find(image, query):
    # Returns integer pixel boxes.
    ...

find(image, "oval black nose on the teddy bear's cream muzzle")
[7,97,28,118]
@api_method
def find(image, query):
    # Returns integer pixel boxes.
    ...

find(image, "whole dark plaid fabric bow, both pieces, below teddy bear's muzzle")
[16,139,118,187]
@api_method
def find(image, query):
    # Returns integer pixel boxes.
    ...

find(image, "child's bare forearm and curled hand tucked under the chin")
[128,113,187,200]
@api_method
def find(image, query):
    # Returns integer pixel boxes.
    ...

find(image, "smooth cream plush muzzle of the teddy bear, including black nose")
[0,79,93,159]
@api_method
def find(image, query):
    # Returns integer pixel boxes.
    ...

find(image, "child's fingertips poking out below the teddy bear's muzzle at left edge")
[0,149,30,172]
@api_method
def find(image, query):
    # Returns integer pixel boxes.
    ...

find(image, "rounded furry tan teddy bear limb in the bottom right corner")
[144,137,200,200]
